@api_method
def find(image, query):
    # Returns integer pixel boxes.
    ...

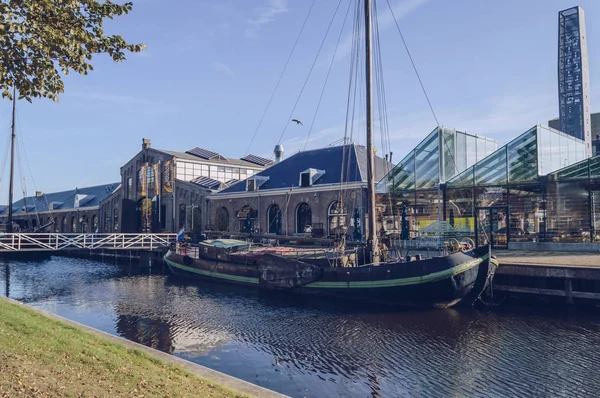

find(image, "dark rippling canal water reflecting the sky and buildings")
[0,257,600,397]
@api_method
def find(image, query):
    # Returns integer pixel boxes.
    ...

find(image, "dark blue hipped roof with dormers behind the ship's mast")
[216,144,393,196]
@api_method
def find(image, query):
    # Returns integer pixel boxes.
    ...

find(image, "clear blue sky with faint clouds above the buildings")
[0,0,600,197]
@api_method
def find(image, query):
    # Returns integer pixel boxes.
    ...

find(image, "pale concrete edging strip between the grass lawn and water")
[0,296,287,398]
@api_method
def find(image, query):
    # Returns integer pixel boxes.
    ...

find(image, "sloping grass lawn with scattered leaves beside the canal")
[0,300,244,398]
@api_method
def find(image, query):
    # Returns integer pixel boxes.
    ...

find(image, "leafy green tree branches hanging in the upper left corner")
[0,0,145,102]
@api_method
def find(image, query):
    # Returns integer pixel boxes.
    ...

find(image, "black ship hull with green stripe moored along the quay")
[164,246,496,308]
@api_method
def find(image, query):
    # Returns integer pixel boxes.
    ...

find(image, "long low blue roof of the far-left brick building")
[0,182,120,215]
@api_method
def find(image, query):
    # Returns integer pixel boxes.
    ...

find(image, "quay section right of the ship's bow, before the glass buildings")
[493,250,600,306]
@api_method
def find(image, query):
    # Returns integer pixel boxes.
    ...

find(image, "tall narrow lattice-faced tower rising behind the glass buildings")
[558,6,592,157]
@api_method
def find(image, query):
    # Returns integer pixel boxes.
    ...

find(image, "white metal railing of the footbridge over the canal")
[0,233,177,252]
